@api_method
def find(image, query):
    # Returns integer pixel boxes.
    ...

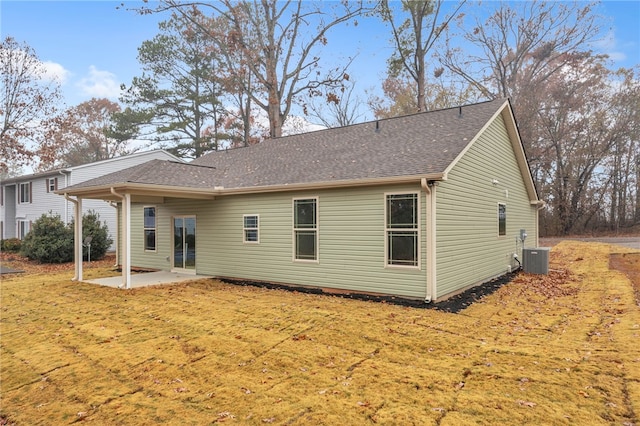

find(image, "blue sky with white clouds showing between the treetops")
[0,0,640,110]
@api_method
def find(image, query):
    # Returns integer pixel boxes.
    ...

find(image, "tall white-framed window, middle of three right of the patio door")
[293,198,318,261]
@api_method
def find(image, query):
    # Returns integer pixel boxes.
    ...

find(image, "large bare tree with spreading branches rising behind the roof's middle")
[138,0,371,137]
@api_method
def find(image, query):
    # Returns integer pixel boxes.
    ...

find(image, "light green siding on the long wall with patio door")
[131,182,426,298]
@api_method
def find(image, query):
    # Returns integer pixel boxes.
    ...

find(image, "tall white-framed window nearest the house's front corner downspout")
[385,192,420,267]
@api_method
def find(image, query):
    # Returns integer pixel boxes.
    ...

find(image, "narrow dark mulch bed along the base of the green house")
[221,271,518,314]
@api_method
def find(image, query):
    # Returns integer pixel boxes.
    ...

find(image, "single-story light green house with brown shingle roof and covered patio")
[58,99,543,301]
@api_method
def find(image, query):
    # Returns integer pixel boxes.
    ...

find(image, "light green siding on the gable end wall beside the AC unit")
[436,115,536,297]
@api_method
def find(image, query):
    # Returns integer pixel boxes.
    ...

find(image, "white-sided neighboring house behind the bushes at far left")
[0,150,181,248]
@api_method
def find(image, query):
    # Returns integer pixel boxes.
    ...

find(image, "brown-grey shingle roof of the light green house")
[65,99,535,201]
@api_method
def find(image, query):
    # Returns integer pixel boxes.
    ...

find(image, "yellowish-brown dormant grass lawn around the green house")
[0,242,640,425]
